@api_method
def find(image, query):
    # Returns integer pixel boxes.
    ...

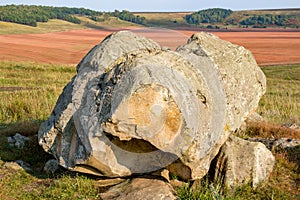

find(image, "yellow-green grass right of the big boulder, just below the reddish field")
[258,64,300,124]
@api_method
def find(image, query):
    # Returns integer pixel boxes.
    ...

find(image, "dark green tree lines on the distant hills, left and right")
[0,5,300,28]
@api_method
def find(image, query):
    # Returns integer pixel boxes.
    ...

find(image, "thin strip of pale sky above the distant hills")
[0,0,300,12]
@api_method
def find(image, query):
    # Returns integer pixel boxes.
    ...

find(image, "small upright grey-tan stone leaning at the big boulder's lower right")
[210,135,275,189]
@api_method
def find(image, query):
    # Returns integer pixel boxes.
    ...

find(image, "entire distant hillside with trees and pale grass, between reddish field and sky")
[0,5,300,31]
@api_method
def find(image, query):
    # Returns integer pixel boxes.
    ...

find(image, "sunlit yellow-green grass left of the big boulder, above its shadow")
[0,62,76,123]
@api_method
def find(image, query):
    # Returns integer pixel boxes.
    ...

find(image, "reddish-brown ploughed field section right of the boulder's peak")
[182,30,300,65]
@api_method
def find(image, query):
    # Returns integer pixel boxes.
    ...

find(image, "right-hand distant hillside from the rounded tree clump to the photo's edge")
[185,8,300,28]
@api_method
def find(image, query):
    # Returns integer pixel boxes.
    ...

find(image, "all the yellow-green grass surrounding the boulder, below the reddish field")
[0,62,300,199]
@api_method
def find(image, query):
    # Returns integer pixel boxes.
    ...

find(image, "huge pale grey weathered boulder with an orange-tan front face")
[38,31,266,179]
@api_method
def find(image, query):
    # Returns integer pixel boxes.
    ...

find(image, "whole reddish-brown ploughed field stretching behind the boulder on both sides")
[0,28,300,65]
